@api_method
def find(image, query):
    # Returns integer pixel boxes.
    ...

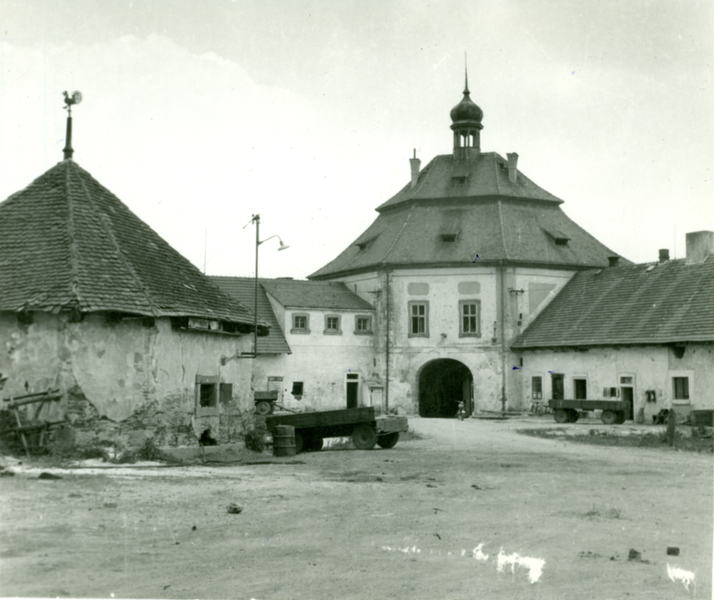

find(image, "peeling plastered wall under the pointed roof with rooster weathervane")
[0,312,252,442]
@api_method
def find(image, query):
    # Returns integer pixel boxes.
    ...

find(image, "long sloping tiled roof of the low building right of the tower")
[511,255,714,349]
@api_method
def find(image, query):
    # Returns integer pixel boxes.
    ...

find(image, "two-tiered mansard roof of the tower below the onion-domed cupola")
[310,153,628,279]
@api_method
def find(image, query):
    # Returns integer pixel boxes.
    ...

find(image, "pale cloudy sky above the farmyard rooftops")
[0,0,714,278]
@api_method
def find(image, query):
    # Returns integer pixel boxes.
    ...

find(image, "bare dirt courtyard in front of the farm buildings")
[0,417,713,600]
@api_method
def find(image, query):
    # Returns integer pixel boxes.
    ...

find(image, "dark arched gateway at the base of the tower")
[419,358,473,418]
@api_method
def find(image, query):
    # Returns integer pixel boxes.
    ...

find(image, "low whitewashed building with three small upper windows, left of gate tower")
[211,277,383,411]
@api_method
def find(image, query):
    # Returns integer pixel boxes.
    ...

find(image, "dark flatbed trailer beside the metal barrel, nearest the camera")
[265,406,409,453]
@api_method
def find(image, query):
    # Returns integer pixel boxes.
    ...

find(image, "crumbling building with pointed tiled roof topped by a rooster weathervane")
[0,158,268,444]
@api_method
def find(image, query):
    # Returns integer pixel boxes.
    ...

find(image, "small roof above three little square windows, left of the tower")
[261,279,374,311]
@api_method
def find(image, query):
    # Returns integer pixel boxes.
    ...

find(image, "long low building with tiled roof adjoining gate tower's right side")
[511,231,714,423]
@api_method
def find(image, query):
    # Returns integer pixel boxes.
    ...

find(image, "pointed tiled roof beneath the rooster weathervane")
[0,160,267,327]
